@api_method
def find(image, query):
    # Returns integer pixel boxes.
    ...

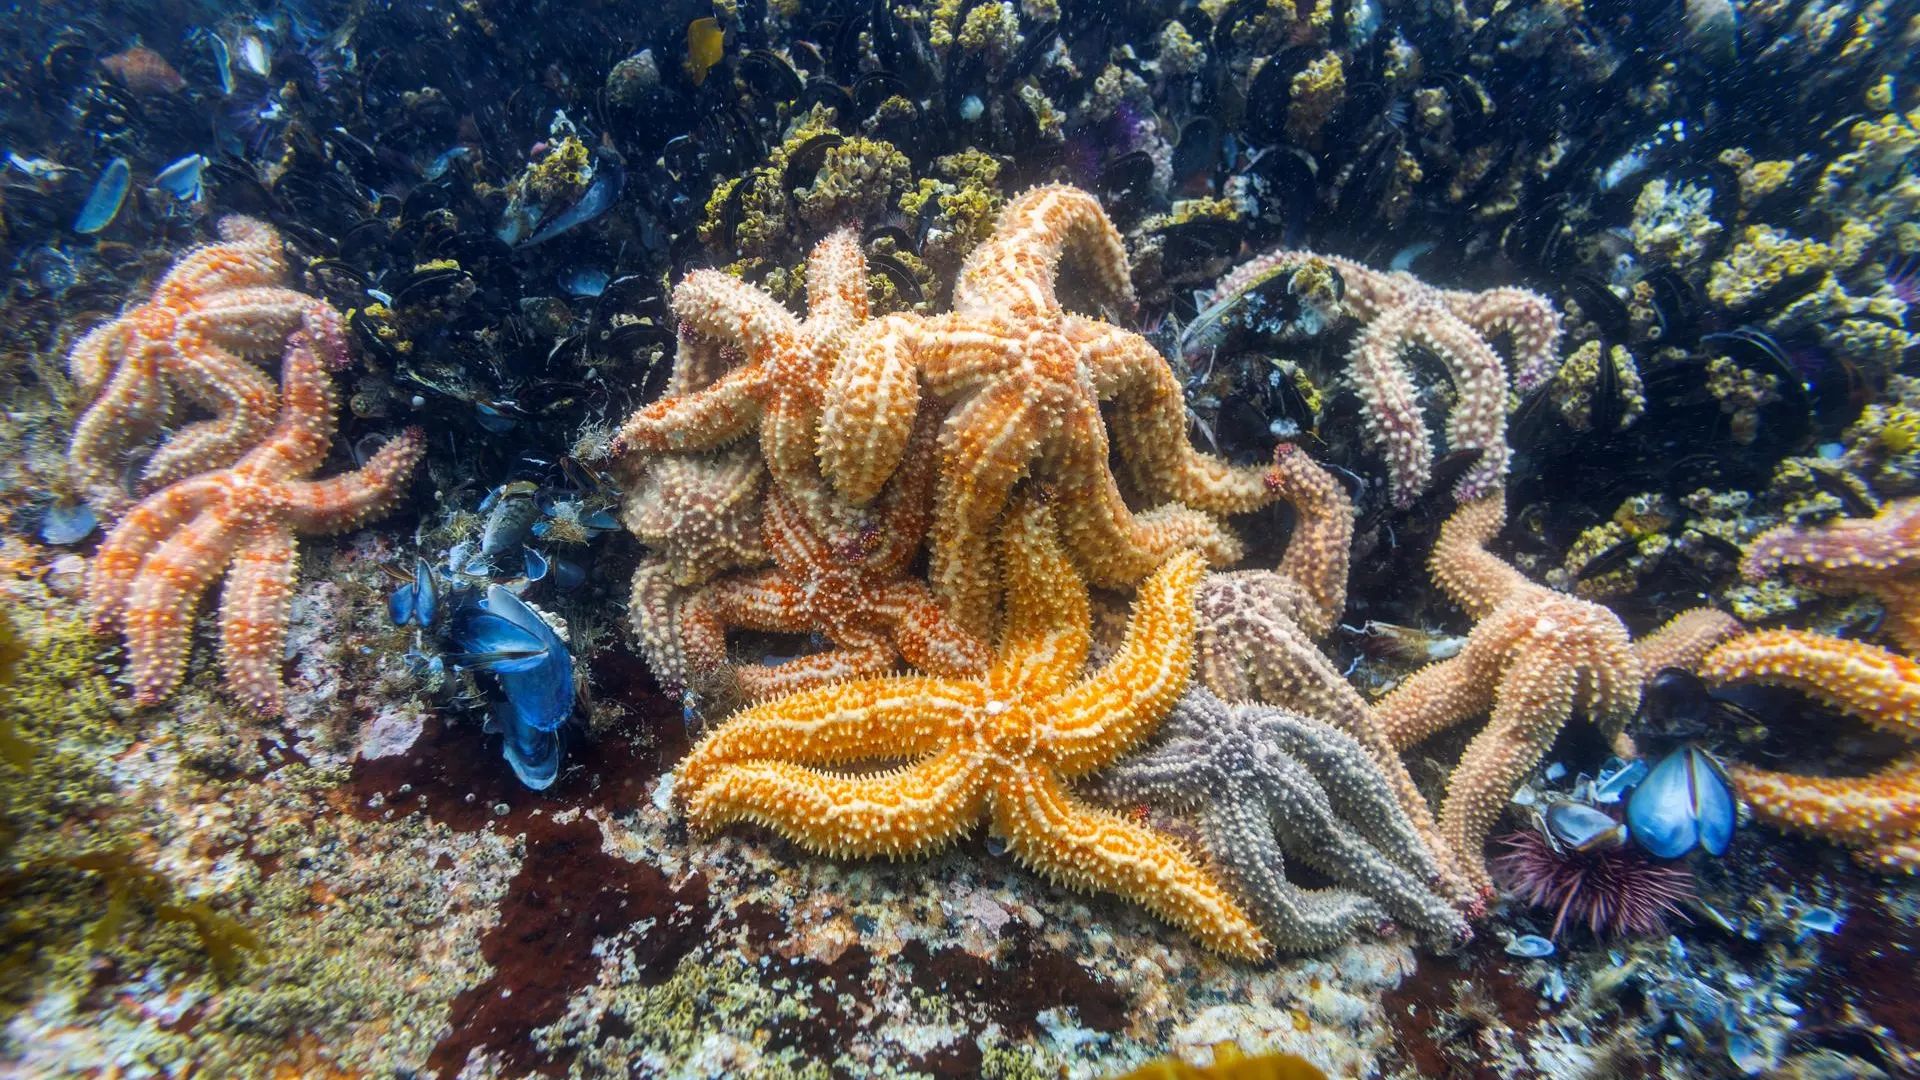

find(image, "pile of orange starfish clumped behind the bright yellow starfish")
[614,186,1273,701]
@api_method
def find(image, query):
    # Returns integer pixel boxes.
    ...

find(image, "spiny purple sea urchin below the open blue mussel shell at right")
[1494,828,1693,940]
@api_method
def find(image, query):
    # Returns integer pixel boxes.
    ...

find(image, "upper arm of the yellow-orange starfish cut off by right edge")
[1699,630,1920,738]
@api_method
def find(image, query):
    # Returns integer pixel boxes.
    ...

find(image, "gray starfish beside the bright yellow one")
[1100,688,1471,951]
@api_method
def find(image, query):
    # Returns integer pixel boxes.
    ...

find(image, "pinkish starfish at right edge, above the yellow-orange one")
[1740,496,1920,653]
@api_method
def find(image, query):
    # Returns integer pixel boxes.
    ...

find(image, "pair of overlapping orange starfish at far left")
[71,217,424,713]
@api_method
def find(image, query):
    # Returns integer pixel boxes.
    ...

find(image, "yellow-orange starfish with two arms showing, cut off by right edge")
[1701,630,1920,872]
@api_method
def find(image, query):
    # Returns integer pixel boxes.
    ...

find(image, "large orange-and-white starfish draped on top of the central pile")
[820,186,1269,632]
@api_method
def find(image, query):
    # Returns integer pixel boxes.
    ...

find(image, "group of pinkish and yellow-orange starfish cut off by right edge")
[1701,498,1920,872]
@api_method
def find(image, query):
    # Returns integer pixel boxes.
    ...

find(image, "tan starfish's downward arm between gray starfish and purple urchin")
[1440,653,1580,892]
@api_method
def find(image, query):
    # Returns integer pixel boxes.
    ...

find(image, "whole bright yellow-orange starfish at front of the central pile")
[676,500,1267,957]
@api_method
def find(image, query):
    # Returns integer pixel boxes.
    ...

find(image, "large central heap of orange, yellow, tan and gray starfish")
[618,186,1774,957]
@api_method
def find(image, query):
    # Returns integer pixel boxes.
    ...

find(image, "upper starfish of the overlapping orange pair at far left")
[67,217,348,511]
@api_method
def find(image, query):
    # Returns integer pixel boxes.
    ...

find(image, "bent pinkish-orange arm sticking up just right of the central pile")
[1265,442,1354,638]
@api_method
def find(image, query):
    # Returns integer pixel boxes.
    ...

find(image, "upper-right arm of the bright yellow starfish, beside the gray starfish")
[1041,553,1206,776]
